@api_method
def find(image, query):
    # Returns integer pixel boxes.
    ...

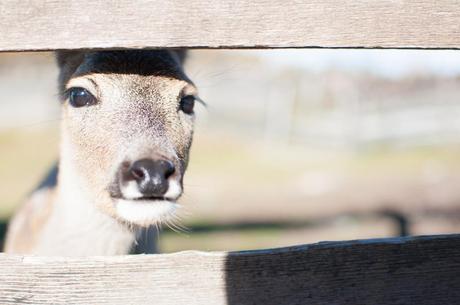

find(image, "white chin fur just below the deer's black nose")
[115,199,178,226]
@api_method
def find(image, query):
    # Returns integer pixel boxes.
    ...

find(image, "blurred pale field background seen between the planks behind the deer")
[0,50,460,252]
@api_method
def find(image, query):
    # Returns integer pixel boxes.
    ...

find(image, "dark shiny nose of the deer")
[123,159,175,197]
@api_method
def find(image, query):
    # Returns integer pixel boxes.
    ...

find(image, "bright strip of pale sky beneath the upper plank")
[253,49,460,78]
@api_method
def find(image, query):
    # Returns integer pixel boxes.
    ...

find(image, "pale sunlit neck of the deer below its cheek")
[35,146,136,256]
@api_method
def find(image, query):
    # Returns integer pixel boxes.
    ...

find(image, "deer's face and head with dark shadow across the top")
[57,50,197,226]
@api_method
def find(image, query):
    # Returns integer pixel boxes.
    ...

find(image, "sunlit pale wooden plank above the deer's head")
[0,0,460,51]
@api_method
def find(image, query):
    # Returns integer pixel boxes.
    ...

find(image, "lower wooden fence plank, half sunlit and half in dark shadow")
[0,235,460,305]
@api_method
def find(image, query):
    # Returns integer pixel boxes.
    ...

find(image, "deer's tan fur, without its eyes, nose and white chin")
[5,50,196,255]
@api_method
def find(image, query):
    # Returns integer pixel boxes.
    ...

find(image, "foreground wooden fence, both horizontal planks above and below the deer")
[0,0,460,305]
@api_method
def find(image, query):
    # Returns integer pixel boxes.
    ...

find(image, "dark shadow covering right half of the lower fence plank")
[225,237,460,305]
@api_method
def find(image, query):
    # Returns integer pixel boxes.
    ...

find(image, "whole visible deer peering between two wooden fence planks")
[4,49,201,256]
